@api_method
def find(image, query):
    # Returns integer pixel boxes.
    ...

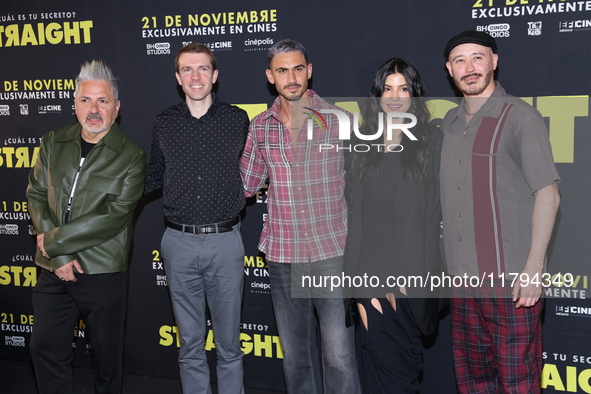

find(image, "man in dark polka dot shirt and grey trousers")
[146,43,249,394]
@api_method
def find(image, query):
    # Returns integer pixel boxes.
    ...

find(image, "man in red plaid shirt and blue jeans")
[240,40,360,394]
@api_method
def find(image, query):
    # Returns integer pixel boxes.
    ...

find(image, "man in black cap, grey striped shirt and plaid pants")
[440,31,560,393]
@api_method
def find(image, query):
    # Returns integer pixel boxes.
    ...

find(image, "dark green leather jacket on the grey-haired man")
[27,123,146,274]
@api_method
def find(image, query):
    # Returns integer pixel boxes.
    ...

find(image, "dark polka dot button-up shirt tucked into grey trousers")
[146,93,249,224]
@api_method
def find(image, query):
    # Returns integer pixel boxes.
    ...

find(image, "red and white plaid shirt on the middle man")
[240,90,347,263]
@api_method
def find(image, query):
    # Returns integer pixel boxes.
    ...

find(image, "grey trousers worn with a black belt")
[162,223,244,394]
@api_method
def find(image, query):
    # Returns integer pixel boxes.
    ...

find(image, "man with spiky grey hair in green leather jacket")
[27,60,145,393]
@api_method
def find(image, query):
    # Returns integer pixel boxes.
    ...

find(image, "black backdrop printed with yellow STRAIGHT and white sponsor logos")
[0,0,591,393]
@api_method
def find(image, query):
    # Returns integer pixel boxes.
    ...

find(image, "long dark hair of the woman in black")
[352,58,430,182]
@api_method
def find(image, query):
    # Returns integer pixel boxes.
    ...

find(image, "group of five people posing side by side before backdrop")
[27,31,559,394]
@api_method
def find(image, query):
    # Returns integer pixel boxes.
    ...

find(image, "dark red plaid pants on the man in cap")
[450,296,543,394]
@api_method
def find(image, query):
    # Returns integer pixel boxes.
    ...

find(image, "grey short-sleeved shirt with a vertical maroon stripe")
[440,82,560,278]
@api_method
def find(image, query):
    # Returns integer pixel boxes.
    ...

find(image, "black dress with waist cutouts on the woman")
[355,152,422,394]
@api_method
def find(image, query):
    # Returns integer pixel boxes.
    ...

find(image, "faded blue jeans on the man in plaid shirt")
[269,257,361,394]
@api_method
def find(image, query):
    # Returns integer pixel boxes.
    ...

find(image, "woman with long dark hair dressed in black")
[345,58,443,394]
